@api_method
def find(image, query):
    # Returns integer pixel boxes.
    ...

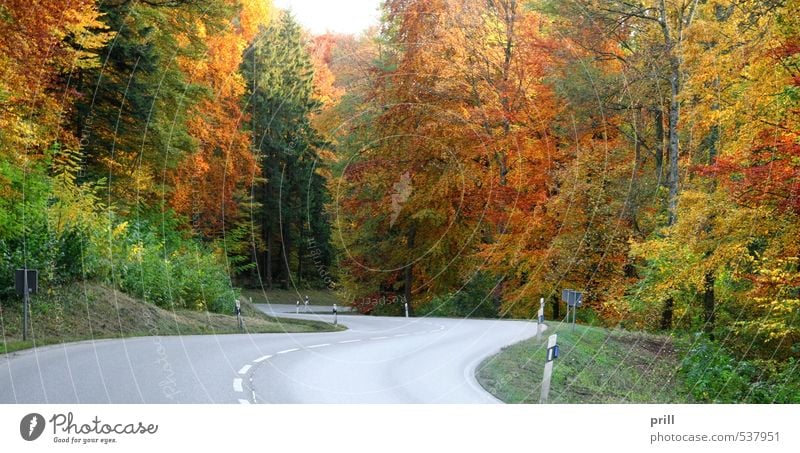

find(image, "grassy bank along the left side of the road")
[0,283,344,353]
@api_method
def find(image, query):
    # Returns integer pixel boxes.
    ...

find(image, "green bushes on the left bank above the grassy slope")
[0,150,238,313]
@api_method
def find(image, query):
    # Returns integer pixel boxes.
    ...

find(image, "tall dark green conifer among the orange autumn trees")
[242,13,332,289]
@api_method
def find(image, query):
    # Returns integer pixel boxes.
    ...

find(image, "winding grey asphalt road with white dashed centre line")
[0,305,536,404]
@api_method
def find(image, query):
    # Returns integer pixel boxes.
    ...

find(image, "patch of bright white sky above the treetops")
[273,0,380,35]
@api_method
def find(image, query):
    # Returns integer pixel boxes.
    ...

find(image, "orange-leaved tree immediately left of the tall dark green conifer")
[170,1,270,238]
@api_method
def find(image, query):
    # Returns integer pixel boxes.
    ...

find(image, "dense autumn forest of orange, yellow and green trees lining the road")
[0,0,800,402]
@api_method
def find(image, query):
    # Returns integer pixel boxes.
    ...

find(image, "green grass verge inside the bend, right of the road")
[477,324,691,403]
